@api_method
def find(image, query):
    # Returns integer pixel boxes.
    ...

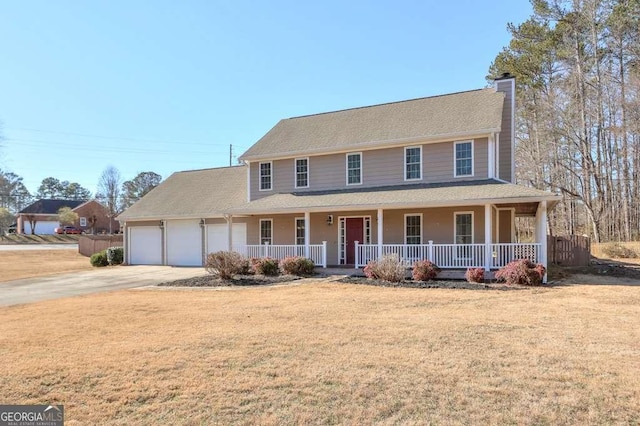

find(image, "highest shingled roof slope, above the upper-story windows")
[240,88,504,161]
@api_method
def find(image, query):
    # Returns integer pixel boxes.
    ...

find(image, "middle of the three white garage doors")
[166,220,202,266]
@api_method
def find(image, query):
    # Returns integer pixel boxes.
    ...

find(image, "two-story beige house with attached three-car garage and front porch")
[119,75,558,280]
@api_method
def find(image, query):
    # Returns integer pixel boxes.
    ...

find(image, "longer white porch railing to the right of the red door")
[355,241,541,269]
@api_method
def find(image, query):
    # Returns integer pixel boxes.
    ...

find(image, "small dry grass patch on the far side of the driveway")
[0,249,92,285]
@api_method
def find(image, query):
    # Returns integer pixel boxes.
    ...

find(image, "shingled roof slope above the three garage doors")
[118,166,247,221]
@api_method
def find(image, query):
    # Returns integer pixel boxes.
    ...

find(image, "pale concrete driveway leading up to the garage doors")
[0,265,206,306]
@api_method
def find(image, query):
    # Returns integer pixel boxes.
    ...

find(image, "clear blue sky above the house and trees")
[0,0,531,193]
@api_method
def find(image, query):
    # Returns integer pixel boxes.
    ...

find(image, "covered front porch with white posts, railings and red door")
[233,201,547,271]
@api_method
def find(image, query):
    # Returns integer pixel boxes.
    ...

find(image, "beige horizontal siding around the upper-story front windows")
[250,138,488,201]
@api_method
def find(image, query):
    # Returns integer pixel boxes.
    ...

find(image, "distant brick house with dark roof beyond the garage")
[17,199,120,235]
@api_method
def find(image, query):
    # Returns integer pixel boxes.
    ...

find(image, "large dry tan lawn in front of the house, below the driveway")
[0,282,640,425]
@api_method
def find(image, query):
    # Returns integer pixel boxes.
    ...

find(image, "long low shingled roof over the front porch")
[226,179,560,214]
